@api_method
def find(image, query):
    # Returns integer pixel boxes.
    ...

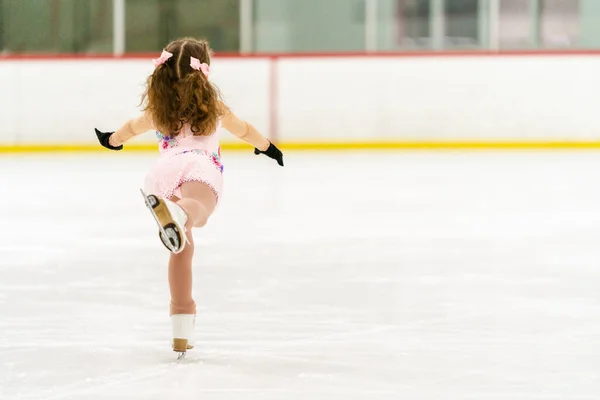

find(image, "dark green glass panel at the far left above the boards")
[0,0,112,53]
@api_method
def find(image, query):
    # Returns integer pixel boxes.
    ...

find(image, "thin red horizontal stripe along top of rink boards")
[0,50,600,62]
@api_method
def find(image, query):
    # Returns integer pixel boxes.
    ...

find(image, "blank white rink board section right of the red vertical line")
[279,56,600,140]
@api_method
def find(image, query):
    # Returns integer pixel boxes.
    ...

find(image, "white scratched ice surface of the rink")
[0,152,600,400]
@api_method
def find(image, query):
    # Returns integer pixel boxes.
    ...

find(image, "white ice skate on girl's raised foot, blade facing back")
[140,189,188,254]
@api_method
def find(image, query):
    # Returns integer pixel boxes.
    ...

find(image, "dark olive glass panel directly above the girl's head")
[125,0,240,52]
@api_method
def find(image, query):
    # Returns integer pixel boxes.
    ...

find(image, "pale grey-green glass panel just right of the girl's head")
[253,0,365,52]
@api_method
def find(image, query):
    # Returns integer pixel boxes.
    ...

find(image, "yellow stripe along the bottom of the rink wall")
[0,141,600,154]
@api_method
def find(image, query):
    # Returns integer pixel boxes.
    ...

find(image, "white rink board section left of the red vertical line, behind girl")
[0,59,270,144]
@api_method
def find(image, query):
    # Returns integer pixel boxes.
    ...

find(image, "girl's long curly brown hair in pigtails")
[142,38,224,136]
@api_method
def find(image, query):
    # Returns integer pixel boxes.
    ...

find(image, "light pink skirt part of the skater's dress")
[145,149,223,203]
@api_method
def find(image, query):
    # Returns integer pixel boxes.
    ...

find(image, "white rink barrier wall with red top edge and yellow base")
[0,51,600,153]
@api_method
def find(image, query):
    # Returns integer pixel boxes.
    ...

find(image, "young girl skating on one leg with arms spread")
[96,38,283,357]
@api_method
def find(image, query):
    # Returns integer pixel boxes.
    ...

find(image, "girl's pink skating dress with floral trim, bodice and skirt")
[145,120,223,203]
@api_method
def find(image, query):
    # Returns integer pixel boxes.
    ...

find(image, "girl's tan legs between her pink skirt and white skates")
[169,182,217,315]
